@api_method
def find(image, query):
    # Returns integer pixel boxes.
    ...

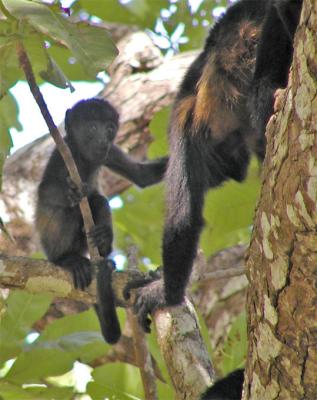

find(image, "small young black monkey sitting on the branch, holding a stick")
[36,99,167,343]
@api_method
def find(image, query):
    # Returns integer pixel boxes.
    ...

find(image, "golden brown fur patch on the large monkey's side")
[192,21,260,139]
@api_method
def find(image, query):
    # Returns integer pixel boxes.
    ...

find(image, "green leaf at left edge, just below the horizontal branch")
[0,290,52,362]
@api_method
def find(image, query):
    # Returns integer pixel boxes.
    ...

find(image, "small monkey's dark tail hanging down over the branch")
[94,260,121,344]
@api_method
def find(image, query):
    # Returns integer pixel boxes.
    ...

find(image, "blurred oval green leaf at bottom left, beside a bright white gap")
[6,346,75,384]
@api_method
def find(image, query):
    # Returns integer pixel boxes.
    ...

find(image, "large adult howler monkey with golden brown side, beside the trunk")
[125,0,302,400]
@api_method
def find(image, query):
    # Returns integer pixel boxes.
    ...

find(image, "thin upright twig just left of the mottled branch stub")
[127,247,158,400]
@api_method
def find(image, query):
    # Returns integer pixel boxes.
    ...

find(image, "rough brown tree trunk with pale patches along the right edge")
[243,1,317,400]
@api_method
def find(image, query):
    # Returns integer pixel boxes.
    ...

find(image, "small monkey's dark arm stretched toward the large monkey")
[104,144,168,188]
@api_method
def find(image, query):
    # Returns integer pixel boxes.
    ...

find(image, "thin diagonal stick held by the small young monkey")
[16,41,99,261]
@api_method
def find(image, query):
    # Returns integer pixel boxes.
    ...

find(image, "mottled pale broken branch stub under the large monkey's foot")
[154,299,215,400]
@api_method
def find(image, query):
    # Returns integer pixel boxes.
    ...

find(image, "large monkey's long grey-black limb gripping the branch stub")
[126,133,209,332]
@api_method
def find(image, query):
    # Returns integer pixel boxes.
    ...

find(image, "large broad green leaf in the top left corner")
[3,0,118,77]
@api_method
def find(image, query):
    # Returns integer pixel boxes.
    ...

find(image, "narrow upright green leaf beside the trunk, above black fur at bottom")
[221,311,248,376]
